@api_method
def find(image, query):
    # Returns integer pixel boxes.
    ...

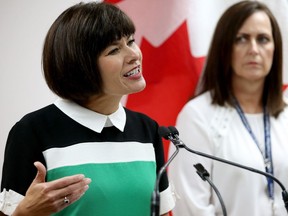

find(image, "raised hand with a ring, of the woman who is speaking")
[13,162,91,216]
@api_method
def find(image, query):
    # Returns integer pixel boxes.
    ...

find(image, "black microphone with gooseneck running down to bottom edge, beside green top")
[150,127,179,216]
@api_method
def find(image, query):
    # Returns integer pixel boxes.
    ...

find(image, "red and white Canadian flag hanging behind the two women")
[108,0,288,155]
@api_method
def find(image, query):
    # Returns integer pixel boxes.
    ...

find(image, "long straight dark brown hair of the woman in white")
[198,1,285,117]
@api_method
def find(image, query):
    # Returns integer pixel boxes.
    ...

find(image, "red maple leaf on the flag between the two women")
[126,22,204,155]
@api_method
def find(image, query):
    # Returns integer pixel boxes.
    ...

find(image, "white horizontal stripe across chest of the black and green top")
[43,142,155,170]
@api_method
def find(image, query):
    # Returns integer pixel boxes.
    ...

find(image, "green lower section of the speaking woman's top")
[48,161,156,216]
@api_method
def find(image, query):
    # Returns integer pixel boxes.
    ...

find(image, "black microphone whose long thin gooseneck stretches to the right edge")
[164,126,288,213]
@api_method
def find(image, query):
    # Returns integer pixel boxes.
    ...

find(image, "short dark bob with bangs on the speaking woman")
[42,2,135,104]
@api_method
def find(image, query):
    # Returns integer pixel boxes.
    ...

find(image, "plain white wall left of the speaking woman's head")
[0,0,288,183]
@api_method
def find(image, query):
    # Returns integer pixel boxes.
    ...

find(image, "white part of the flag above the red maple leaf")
[118,0,231,57]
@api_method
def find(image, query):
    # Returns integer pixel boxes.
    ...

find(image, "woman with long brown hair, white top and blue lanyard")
[169,1,288,216]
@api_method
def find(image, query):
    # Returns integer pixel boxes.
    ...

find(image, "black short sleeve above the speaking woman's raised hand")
[1,121,45,195]
